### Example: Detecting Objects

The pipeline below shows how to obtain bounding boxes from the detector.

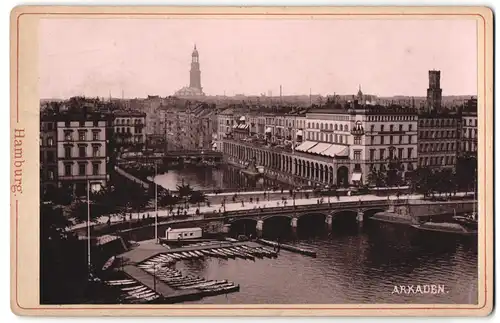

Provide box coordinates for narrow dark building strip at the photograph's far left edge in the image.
[40,113,57,192]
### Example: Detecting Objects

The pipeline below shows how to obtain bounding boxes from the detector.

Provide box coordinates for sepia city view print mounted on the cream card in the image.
[11,5,493,318]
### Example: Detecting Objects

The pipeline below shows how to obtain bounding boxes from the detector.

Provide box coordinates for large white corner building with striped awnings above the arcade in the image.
[296,101,417,186]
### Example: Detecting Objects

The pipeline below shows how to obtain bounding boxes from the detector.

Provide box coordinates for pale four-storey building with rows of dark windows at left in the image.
[56,108,112,196]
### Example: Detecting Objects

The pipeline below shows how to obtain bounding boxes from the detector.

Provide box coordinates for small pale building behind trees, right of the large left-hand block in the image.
[113,111,146,144]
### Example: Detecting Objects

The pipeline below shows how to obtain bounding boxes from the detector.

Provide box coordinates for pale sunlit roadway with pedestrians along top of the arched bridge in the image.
[72,193,466,229]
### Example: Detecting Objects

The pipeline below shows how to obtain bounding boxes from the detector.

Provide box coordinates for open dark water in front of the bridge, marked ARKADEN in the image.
[176,224,478,304]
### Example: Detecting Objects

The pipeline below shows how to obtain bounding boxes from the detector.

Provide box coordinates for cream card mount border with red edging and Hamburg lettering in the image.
[10,6,494,316]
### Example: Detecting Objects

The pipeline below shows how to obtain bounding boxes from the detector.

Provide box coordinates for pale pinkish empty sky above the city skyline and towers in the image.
[39,18,477,98]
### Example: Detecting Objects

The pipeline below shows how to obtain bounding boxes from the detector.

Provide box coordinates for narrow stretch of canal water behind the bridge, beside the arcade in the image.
[155,165,290,190]
